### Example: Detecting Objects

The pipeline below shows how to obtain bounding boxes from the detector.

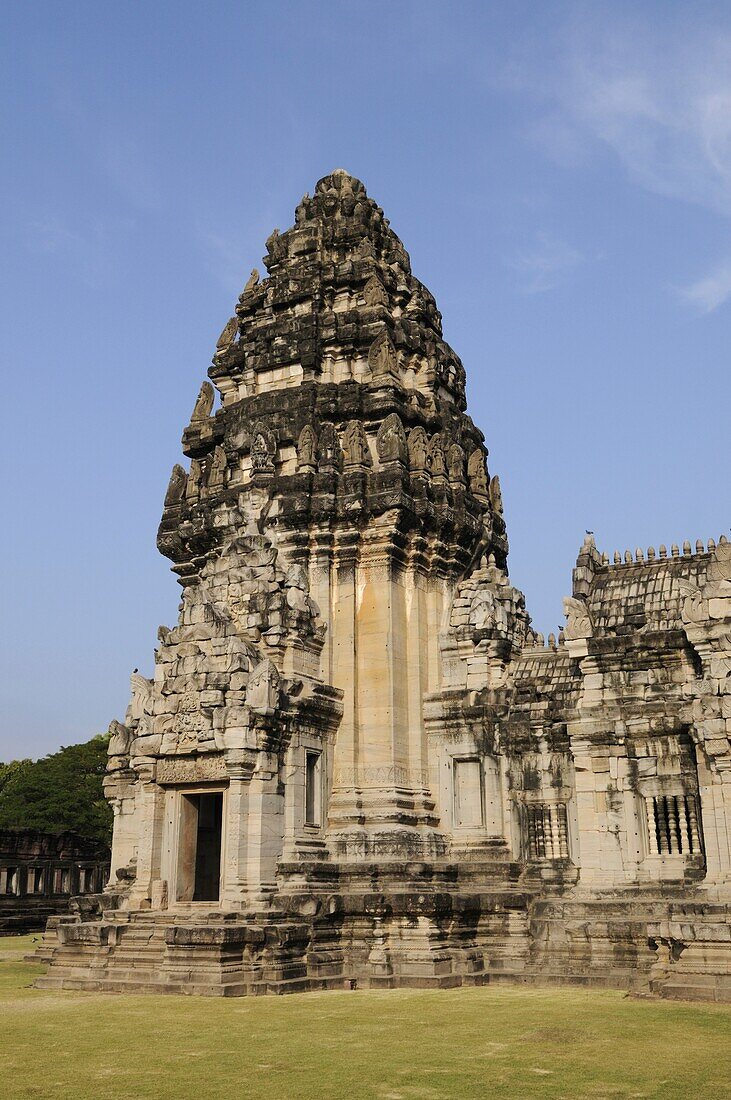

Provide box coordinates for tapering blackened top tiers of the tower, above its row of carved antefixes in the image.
[210,168,465,409]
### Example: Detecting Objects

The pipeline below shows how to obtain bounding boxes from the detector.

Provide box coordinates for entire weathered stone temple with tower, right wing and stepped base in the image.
[38,169,731,1000]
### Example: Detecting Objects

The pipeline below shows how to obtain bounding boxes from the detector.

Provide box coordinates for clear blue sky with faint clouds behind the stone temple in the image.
[0,0,731,759]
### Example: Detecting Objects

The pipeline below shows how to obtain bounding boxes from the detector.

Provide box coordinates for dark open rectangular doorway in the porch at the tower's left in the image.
[177,791,223,901]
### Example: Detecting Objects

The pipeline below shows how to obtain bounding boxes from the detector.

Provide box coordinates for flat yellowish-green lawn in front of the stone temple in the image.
[0,936,731,1100]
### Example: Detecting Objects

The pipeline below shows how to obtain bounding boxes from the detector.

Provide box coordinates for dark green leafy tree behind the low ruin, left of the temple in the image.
[0,735,113,844]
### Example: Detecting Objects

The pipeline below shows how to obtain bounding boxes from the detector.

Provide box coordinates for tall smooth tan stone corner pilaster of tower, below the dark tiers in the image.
[330,525,444,859]
